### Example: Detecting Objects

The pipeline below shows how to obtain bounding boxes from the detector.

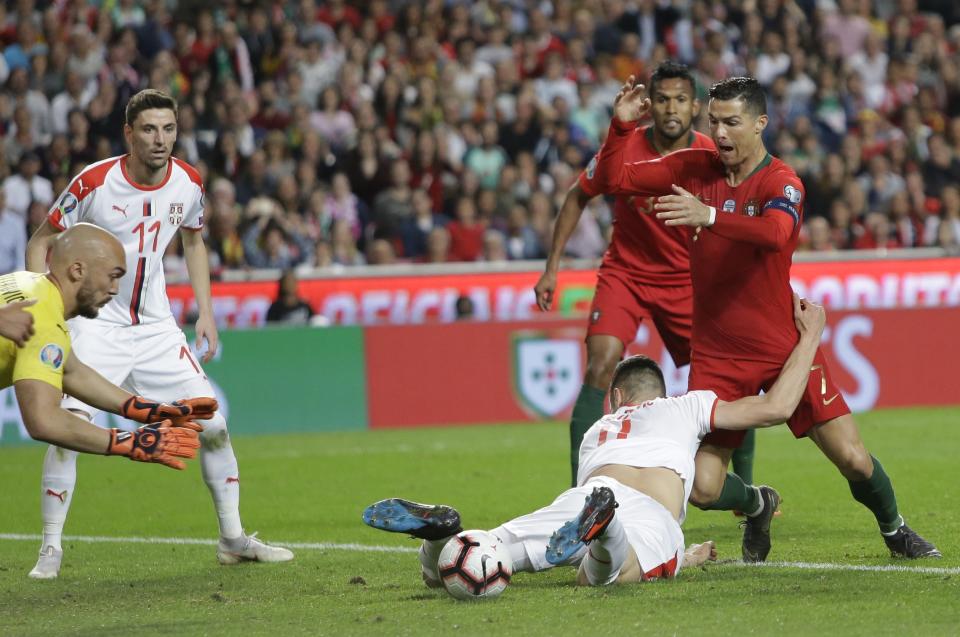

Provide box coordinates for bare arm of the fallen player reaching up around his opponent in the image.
[713,294,827,429]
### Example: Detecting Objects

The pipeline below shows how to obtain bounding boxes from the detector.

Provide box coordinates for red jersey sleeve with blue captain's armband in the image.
[710,166,804,250]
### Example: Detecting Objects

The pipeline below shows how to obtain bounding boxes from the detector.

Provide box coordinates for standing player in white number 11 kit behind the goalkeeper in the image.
[27,89,293,578]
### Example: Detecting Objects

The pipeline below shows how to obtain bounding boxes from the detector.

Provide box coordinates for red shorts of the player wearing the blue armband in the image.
[689,348,850,449]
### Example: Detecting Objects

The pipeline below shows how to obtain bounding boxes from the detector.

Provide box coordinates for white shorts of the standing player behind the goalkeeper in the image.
[61,317,214,418]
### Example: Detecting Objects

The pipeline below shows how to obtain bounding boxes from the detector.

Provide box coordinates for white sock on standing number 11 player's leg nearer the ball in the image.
[200,412,243,539]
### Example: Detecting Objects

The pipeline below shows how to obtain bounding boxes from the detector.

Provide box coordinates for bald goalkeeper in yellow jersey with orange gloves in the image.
[0,224,217,469]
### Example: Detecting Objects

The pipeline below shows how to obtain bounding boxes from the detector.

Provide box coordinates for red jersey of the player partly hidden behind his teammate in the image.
[579,126,714,285]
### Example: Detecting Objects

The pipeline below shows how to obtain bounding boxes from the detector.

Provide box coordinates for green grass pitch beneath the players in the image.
[0,409,960,637]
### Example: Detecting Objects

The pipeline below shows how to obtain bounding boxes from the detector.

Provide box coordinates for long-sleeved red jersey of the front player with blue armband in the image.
[594,120,804,363]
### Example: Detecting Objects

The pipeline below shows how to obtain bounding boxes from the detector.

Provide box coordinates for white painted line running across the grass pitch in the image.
[0,533,960,575]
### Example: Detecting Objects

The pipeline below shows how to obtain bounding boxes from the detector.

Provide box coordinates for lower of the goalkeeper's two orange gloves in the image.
[107,420,200,471]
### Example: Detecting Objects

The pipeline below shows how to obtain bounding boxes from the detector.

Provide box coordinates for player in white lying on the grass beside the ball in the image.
[363,296,826,586]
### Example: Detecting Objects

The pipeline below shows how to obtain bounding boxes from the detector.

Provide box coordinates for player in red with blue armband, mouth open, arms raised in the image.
[594,76,940,561]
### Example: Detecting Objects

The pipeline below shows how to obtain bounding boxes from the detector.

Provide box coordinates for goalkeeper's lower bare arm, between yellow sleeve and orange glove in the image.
[14,379,110,455]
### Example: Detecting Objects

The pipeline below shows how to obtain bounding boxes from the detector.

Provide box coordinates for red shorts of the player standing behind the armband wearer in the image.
[587,268,693,367]
